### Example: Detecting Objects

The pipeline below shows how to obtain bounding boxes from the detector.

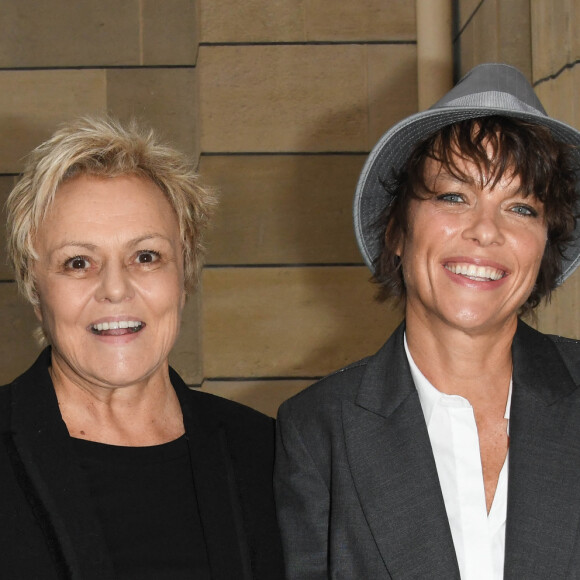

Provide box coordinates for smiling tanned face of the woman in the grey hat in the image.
[397,152,547,333]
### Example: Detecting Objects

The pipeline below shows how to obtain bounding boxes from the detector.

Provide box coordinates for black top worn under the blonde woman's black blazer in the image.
[74,435,210,580]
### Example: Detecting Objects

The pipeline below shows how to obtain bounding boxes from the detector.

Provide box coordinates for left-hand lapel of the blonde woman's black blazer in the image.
[8,349,114,580]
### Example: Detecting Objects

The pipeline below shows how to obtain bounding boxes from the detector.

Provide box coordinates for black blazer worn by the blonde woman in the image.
[0,349,283,580]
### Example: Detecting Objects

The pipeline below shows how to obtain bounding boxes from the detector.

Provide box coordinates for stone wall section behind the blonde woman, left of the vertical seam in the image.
[0,0,202,384]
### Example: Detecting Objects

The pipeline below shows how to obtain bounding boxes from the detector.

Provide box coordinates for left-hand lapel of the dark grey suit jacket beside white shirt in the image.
[343,326,459,580]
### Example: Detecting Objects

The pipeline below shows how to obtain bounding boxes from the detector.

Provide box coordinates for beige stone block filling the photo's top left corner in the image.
[0,0,140,67]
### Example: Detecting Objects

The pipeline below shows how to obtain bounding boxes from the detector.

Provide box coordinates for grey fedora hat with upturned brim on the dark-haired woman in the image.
[353,63,580,284]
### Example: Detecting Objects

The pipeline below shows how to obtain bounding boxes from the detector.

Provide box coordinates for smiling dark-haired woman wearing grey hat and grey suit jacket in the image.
[275,64,580,580]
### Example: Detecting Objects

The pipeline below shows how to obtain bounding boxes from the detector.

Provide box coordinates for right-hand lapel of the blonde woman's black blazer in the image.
[170,371,252,580]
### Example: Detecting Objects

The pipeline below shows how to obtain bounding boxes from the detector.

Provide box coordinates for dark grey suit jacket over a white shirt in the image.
[275,322,580,580]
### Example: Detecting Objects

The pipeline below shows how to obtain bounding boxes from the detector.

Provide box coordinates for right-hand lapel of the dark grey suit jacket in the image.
[505,323,580,580]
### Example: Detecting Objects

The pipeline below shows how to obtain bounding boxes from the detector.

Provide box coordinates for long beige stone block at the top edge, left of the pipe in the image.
[201,0,415,43]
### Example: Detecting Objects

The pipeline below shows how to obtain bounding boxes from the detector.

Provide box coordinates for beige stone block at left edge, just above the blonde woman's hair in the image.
[0,70,106,173]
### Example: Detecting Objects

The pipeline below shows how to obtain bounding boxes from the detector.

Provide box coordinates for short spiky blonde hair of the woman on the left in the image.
[6,117,216,305]
